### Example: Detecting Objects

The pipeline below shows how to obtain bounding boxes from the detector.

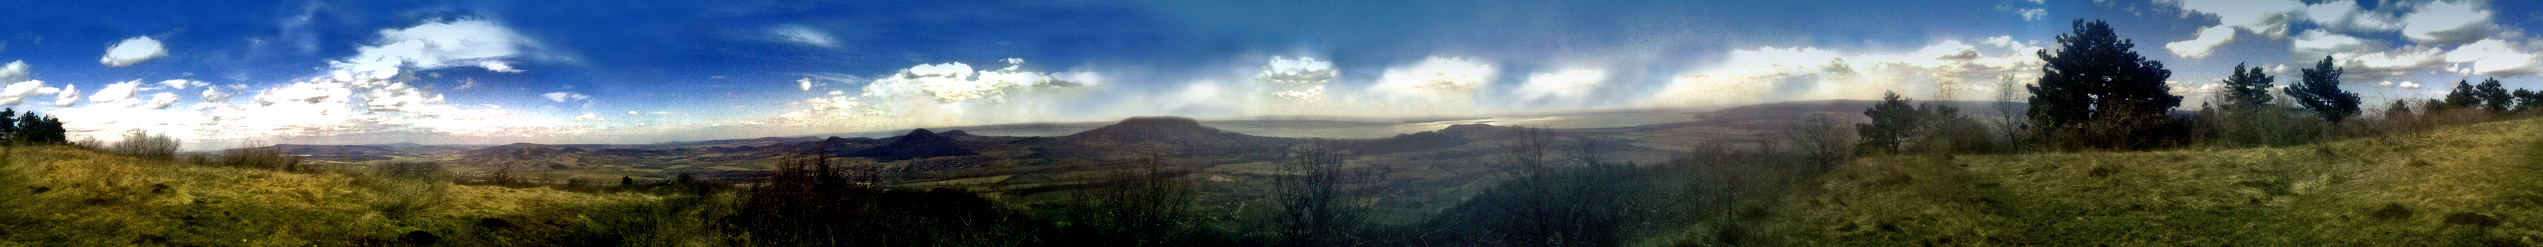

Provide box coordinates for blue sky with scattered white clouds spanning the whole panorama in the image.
[0,0,2543,150]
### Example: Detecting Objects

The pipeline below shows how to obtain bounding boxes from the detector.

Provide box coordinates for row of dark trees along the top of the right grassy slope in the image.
[1856,20,2543,153]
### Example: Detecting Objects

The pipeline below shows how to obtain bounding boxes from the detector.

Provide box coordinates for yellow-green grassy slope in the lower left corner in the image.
[0,145,656,247]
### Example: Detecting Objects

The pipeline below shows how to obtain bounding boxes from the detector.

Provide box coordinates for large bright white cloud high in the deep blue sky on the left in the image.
[328,20,537,74]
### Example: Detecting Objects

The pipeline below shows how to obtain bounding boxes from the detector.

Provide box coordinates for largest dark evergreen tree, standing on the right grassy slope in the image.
[2029,20,2182,148]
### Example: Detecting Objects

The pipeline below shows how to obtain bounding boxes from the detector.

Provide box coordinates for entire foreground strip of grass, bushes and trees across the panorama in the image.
[0,20,2543,247]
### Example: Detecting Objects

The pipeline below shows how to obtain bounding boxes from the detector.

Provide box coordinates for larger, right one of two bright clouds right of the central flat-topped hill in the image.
[1368,56,1498,99]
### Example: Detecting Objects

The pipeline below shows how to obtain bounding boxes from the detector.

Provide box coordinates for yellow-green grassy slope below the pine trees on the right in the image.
[1739,120,2543,247]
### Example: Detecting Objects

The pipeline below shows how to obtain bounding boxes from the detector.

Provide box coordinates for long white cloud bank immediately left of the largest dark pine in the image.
[1645,36,2039,107]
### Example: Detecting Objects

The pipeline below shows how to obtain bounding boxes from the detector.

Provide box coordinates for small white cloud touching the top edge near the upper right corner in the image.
[2401,0,2492,46]
